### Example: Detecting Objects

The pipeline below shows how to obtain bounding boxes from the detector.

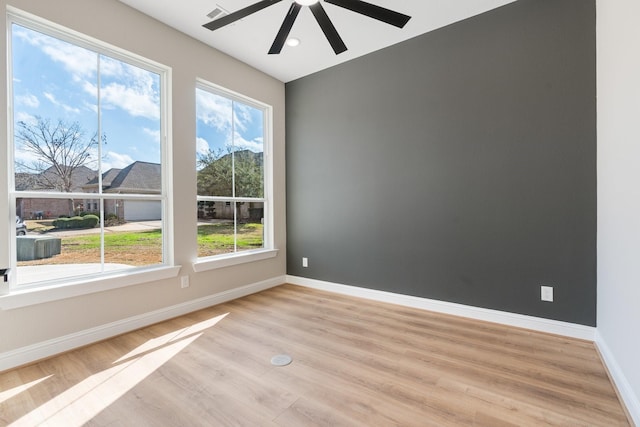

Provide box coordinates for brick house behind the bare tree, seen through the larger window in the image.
[15,166,97,219]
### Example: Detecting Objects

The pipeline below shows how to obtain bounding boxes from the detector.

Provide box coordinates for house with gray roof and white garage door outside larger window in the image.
[82,161,162,221]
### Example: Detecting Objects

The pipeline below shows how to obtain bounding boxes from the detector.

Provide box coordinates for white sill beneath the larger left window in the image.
[0,266,180,310]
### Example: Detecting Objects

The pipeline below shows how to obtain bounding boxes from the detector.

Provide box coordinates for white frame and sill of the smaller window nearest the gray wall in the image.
[192,78,278,272]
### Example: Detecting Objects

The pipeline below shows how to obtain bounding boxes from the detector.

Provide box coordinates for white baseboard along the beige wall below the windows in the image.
[0,276,286,372]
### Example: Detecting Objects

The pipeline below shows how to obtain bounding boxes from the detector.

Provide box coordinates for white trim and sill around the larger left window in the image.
[0,6,181,300]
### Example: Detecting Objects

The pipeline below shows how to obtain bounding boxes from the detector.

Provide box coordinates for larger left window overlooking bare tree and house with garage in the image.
[8,13,172,288]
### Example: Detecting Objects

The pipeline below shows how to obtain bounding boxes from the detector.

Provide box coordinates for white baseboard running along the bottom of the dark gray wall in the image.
[287,276,596,341]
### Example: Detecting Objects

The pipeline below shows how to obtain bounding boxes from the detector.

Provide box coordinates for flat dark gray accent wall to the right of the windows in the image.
[286,0,596,326]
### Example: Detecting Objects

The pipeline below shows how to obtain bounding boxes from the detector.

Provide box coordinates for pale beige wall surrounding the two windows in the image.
[0,0,286,360]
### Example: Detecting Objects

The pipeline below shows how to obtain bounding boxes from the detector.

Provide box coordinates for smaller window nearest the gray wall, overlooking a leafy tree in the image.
[196,82,272,266]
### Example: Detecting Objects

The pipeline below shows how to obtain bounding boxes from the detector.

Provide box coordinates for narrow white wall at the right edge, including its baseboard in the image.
[597,0,640,425]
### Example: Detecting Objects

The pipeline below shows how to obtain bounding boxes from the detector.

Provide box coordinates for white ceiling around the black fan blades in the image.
[120,0,515,82]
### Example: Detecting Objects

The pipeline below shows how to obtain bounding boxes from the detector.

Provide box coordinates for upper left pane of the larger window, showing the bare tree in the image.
[12,24,98,195]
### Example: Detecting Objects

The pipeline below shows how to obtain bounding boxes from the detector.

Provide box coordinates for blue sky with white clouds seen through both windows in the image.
[12,24,264,176]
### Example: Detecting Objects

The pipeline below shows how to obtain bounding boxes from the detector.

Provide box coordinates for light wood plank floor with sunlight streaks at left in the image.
[0,285,629,427]
